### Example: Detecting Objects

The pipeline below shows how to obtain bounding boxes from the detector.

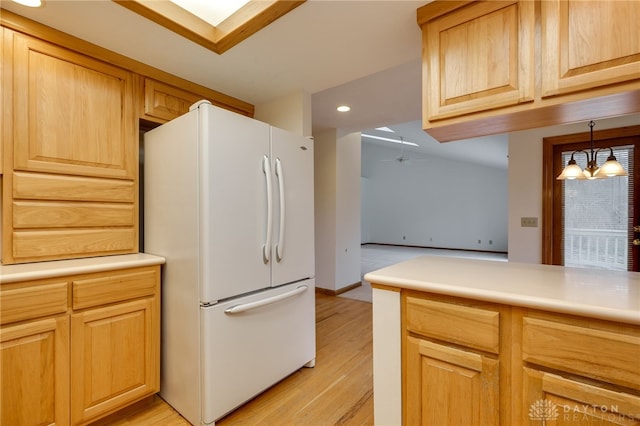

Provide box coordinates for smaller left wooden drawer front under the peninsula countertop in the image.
[406,296,500,354]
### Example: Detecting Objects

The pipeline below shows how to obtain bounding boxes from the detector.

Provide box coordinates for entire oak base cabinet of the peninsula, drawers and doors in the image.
[401,289,640,425]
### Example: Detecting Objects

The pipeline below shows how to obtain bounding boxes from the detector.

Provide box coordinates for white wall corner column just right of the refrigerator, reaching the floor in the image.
[314,129,360,291]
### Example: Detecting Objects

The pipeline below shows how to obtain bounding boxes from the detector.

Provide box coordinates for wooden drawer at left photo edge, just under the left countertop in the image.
[0,281,68,324]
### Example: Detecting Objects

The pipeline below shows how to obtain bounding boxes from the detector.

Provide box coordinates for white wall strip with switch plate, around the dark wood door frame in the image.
[509,114,640,263]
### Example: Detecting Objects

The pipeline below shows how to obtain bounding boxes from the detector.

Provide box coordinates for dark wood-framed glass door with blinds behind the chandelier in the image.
[542,126,640,271]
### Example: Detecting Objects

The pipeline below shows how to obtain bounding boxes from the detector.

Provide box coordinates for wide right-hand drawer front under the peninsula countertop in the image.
[522,317,640,389]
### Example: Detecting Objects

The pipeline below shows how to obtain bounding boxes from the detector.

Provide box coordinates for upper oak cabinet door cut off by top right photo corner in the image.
[540,0,640,97]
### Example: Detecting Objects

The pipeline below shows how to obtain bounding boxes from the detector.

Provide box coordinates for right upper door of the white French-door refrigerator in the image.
[271,127,315,286]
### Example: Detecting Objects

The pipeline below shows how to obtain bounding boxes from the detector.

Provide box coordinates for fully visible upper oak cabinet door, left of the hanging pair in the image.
[422,1,534,120]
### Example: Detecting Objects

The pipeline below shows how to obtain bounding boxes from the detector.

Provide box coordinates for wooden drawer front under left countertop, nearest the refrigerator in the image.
[72,267,159,310]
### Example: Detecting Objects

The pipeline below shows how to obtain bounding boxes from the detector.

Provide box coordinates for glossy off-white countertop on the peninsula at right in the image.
[364,256,640,324]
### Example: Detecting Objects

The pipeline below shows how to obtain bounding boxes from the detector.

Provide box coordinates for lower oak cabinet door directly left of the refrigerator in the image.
[71,298,160,424]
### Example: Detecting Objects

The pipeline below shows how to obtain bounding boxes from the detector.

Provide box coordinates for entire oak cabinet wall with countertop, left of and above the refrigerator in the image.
[0,9,254,426]
